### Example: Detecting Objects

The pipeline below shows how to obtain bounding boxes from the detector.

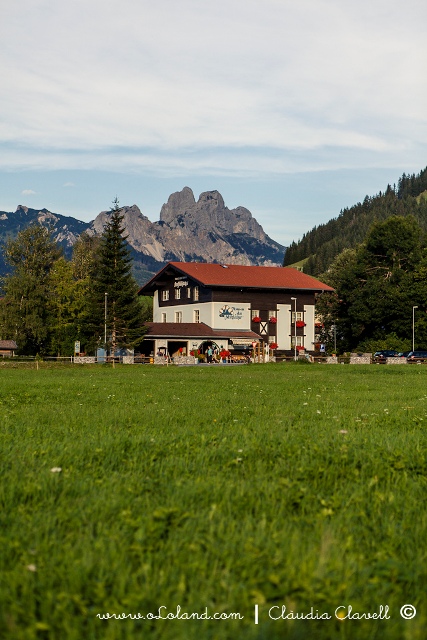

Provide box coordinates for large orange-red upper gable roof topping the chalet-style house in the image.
[141,262,333,291]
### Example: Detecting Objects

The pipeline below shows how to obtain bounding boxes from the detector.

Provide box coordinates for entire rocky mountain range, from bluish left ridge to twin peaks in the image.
[0,187,285,284]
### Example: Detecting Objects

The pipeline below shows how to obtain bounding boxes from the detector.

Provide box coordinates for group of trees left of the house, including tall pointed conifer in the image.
[0,199,151,356]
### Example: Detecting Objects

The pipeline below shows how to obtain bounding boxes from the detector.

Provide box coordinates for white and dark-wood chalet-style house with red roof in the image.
[139,262,333,356]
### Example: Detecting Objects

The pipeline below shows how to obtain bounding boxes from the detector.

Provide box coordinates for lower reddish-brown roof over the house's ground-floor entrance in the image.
[144,322,260,340]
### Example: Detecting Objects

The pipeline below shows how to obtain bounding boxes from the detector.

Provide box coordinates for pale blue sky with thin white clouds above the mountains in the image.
[0,0,427,245]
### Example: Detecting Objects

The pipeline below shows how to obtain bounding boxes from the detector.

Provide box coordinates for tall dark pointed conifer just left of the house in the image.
[94,198,143,353]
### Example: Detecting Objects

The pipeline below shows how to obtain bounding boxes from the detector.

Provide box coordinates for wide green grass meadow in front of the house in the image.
[0,364,427,640]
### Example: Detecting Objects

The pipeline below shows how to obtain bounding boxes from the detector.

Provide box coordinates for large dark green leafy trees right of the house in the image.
[316,215,427,353]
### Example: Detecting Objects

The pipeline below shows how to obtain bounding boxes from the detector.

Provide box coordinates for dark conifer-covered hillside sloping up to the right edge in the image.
[284,167,427,276]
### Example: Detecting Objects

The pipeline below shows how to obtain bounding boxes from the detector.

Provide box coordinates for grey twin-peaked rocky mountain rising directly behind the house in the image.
[88,187,284,274]
